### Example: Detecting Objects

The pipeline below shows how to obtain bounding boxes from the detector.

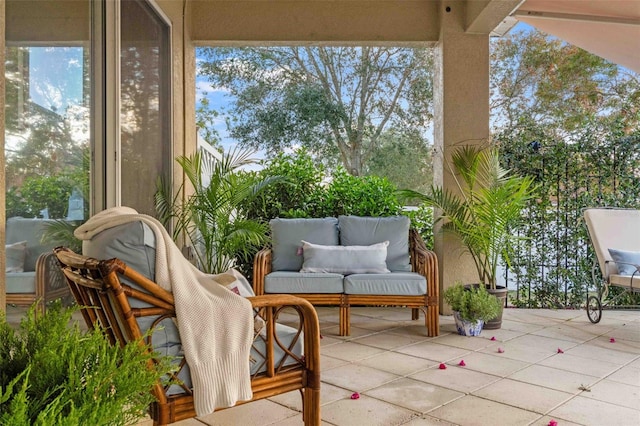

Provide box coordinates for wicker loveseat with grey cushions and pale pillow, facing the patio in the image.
[253,216,439,336]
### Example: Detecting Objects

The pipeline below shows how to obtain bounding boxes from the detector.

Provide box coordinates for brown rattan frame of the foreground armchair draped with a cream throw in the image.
[54,247,320,425]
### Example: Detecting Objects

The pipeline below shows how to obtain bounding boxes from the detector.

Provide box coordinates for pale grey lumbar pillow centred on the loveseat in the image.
[300,240,389,275]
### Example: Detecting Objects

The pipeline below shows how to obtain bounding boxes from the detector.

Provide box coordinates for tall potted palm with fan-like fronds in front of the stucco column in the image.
[402,144,534,329]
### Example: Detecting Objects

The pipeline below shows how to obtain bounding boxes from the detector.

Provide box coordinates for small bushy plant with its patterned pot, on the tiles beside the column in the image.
[443,282,500,336]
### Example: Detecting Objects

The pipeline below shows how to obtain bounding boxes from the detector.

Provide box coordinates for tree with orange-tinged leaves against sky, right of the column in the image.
[490,30,640,136]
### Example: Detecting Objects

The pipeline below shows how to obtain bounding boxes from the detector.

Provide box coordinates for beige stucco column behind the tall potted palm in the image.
[433,1,489,314]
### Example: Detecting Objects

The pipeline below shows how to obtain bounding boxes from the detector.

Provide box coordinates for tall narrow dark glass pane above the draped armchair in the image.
[120,0,171,215]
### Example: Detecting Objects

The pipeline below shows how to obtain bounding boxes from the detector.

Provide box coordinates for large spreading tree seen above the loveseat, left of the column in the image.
[199,47,432,175]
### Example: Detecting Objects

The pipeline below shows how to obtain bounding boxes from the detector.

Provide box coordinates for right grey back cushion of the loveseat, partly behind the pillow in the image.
[338,216,411,272]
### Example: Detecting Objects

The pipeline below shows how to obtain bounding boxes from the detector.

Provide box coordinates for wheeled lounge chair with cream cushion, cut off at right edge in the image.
[584,208,640,324]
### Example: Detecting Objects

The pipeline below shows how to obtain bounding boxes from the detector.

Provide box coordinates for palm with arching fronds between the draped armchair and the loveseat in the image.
[155,149,277,273]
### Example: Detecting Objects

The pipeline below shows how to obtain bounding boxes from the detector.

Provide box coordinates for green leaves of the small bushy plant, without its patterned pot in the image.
[443,283,500,321]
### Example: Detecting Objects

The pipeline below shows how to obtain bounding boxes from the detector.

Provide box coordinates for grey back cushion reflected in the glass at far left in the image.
[5,217,58,272]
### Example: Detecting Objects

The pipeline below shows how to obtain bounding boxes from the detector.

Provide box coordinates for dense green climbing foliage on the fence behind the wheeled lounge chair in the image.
[498,122,640,308]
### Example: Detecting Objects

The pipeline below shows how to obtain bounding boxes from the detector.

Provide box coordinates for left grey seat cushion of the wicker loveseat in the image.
[264,271,344,294]
